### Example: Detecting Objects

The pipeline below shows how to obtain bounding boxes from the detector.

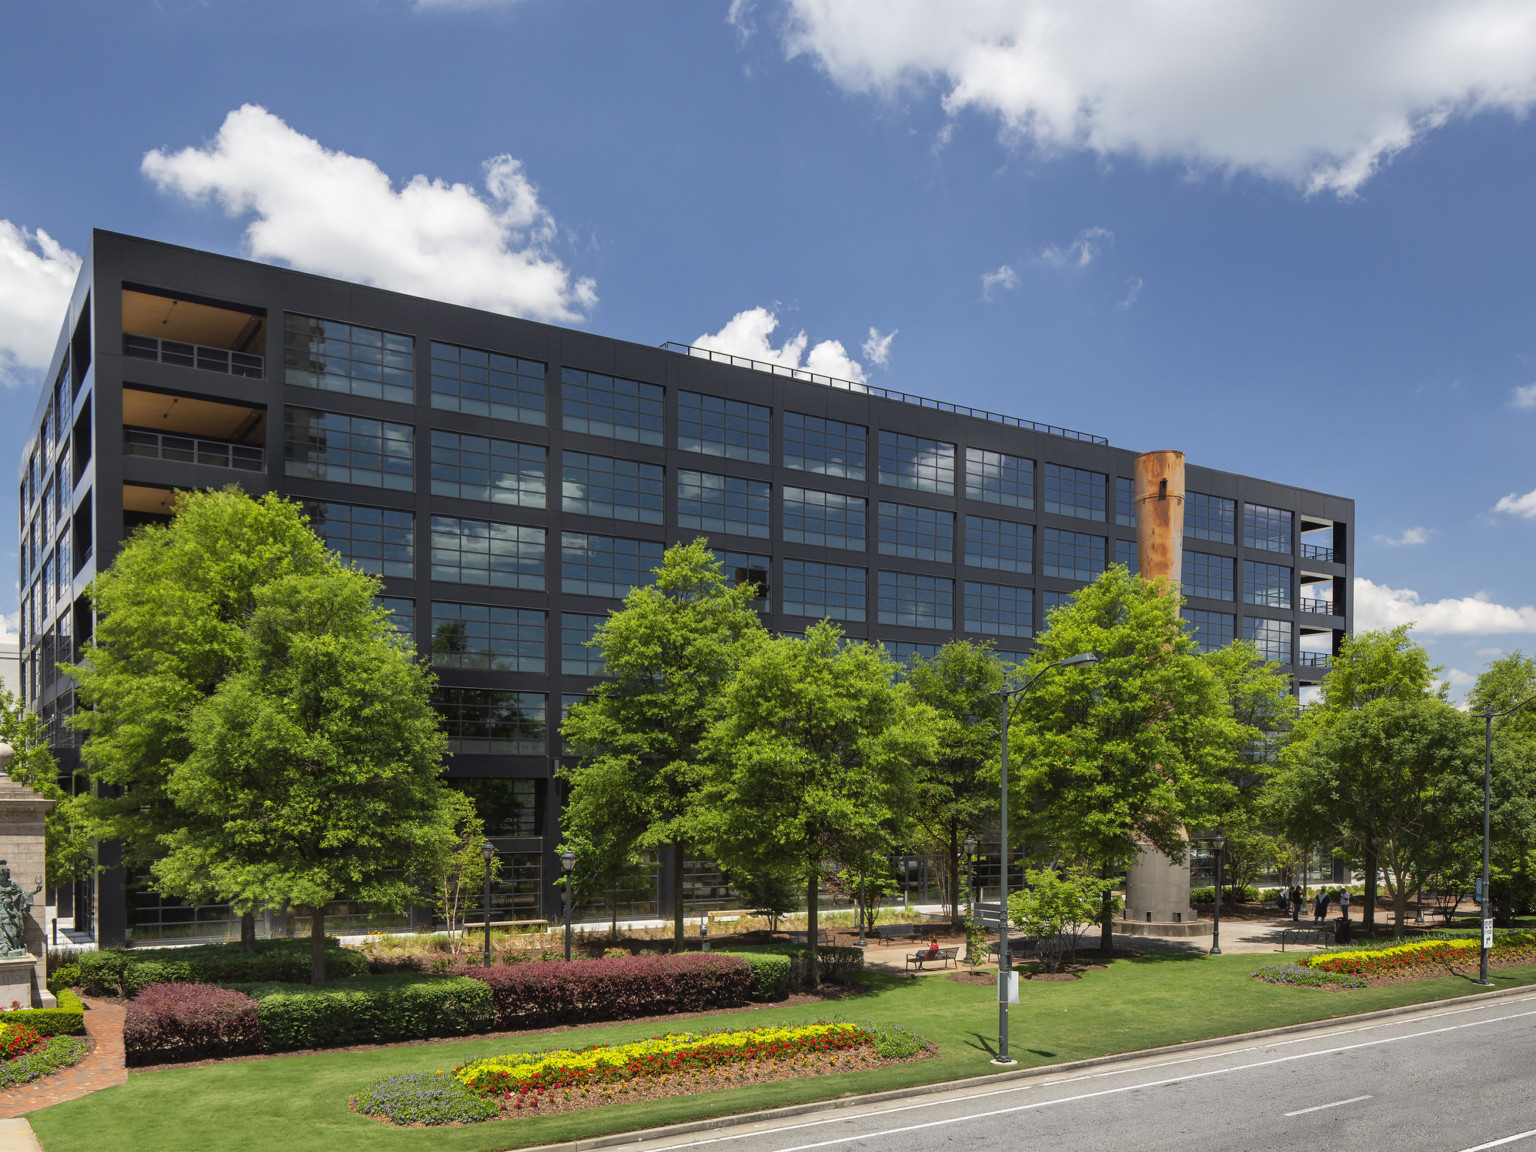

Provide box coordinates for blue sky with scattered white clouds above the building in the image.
[0,0,1536,687]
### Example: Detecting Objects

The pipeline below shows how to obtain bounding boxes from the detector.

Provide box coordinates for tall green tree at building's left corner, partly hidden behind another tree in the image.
[68,485,332,946]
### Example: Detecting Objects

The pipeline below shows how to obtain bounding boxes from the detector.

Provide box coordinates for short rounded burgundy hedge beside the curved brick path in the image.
[123,985,261,1064]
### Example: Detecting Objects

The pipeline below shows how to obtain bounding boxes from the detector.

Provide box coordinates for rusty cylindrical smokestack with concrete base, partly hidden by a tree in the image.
[1115,450,1210,935]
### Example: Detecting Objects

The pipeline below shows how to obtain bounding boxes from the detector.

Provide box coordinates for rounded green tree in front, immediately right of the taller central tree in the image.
[694,621,935,980]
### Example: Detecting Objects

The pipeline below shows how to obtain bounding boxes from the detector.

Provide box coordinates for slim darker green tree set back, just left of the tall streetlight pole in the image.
[906,641,1003,923]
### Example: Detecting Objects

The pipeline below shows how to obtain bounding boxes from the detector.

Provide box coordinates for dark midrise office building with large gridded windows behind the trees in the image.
[17,232,1355,943]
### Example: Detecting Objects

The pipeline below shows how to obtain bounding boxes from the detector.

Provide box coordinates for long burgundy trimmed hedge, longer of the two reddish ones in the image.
[458,952,753,1029]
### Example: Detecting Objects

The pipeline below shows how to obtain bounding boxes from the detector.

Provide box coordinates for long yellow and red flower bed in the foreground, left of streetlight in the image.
[352,1021,935,1124]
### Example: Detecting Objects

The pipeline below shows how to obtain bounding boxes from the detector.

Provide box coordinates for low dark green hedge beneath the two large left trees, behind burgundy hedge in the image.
[62,940,369,995]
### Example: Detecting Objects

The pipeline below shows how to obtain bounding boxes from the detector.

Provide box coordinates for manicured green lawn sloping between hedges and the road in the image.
[29,955,1536,1152]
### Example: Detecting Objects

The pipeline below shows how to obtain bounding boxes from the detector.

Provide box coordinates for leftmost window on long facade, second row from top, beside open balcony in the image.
[283,407,415,492]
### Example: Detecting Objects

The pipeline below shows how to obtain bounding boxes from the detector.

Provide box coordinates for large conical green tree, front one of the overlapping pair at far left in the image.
[151,561,467,986]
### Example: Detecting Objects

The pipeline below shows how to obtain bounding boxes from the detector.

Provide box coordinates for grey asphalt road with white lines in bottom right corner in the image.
[630,992,1536,1152]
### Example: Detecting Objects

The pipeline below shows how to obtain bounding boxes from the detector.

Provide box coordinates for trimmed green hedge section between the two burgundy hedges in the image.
[240,969,496,1052]
